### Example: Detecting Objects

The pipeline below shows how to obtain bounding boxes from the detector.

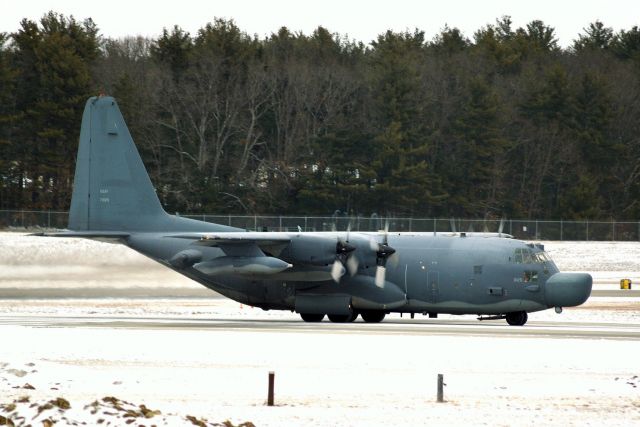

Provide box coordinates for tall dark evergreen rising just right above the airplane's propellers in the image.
[368,30,444,215]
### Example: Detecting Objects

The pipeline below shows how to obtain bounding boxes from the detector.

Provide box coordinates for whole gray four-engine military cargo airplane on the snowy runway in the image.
[44,96,592,325]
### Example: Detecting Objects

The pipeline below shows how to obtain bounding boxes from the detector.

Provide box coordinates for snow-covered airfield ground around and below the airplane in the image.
[0,233,640,426]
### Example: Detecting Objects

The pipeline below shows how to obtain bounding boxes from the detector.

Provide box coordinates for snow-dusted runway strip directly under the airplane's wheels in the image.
[0,315,640,340]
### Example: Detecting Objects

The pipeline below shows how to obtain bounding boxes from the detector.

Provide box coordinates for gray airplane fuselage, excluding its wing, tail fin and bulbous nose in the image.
[125,233,568,314]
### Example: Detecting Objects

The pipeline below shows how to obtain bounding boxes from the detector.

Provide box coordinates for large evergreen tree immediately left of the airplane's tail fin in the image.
[12,12,99,209]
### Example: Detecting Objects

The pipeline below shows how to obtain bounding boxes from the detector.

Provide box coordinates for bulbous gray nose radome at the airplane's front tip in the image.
[544,273,593,307]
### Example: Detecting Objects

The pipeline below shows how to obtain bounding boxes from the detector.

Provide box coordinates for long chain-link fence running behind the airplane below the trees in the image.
[0,210,640,241]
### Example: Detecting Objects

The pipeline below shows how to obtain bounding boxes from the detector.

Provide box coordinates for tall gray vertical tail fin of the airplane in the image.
[68,96,169,231]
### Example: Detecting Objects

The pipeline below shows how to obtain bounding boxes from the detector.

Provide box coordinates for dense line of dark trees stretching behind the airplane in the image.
[0,12,640,219]
